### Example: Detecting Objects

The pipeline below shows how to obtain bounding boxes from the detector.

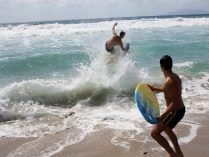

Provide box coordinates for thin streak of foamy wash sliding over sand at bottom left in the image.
[8,130,85,157]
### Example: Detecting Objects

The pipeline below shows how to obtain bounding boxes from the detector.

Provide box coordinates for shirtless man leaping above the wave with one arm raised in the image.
[105,23,126,54]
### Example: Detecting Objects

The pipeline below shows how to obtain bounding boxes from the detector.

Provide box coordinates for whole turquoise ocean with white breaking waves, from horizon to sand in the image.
[0,15,209,156]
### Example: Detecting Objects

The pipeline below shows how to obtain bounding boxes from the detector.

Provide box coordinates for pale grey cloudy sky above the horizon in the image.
[0,0,209,23]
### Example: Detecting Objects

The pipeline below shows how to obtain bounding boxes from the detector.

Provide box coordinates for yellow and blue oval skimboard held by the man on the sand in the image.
[134,83,160,124]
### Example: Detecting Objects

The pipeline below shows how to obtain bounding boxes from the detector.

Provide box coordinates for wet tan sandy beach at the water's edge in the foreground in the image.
[0,114,209,157]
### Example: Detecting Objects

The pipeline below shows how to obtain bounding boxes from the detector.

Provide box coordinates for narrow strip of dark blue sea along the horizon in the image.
[0,14,209,27]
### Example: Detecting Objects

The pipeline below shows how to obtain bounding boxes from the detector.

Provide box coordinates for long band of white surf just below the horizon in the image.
[0,17,209,38]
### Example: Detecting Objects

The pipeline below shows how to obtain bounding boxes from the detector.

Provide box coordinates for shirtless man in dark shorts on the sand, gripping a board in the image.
[149,55,185,157]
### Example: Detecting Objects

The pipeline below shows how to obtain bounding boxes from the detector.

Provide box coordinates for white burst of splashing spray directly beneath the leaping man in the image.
[73,50,148,91]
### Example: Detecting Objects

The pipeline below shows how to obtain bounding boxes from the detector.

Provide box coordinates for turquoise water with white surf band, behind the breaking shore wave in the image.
[0,17,209,86]
